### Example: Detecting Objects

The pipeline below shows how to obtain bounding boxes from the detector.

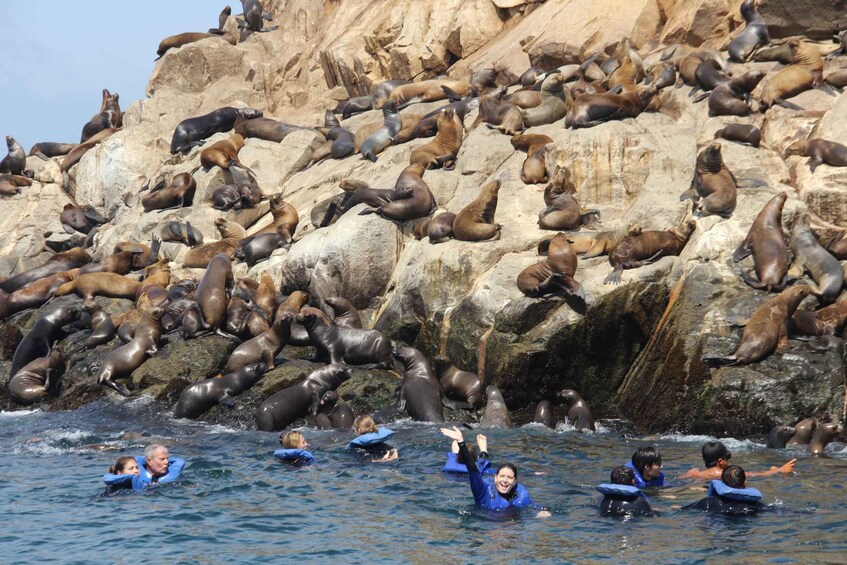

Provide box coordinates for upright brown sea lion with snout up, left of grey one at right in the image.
[732,192,788,292]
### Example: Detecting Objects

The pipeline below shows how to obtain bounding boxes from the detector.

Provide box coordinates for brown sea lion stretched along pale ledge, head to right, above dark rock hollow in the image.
[603,220,697,284]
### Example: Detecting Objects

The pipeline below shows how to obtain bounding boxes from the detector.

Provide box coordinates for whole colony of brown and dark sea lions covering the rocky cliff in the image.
[0,0,847,440]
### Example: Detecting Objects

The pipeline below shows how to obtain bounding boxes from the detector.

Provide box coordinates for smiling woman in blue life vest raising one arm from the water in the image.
[441,427,550,518]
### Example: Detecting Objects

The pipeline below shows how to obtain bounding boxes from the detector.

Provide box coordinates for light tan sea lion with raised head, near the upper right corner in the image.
[759,39,823,112]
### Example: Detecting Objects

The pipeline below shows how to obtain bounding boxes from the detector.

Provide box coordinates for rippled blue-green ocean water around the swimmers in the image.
[0,399,847,564]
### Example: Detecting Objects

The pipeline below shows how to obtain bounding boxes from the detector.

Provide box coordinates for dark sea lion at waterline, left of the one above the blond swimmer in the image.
[174,363,265,420]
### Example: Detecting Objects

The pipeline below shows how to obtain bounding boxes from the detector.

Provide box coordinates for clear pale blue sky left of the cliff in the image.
[0,0,229,152]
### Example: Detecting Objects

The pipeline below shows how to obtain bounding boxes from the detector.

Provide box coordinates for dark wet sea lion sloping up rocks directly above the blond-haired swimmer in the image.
[256,363,350,432]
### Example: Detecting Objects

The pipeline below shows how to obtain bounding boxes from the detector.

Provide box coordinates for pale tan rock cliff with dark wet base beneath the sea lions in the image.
[0,0,847,435]
